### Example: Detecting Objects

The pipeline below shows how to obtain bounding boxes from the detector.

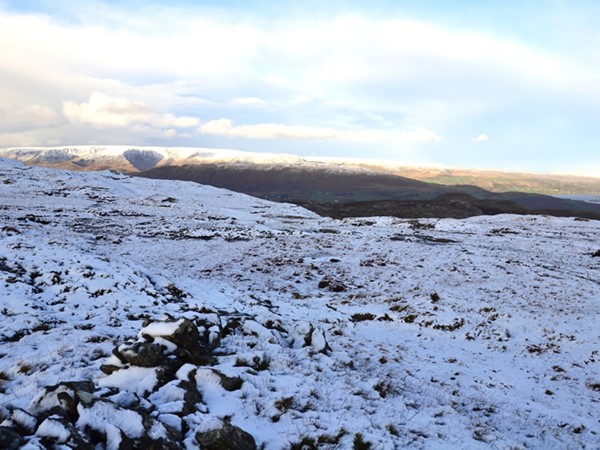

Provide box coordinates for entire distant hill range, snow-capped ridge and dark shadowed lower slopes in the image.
[0,146,600,220]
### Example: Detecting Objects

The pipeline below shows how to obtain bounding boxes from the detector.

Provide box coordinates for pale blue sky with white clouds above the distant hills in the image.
[0,0,600,177]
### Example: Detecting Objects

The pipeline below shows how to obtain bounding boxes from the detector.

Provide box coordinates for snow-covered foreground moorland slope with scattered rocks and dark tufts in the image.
[0,159,600,450]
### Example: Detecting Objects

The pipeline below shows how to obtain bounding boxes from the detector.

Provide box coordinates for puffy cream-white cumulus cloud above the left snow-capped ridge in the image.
[63,92,199,128]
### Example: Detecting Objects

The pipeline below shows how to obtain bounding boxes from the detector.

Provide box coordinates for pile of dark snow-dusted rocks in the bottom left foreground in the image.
[0,317,256,450]
